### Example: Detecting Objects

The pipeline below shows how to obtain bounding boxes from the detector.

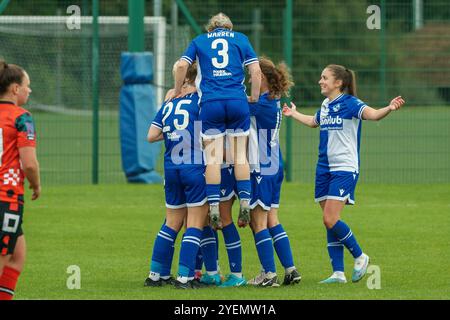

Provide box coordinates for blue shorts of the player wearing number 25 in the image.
[164,166,207,209]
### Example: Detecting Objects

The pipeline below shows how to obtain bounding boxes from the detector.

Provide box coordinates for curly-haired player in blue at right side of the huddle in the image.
[244,57,301,287]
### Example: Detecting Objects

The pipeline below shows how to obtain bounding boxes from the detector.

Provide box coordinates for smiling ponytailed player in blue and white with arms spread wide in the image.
[283,64,405,283]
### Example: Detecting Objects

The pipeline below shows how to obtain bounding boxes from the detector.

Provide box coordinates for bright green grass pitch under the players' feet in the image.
[16,183,450,300]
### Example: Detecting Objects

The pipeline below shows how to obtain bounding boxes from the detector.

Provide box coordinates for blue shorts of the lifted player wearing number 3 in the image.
[200,99,250,139]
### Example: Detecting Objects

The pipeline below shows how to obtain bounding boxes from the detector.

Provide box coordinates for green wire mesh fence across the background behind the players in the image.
[0,0,450,184]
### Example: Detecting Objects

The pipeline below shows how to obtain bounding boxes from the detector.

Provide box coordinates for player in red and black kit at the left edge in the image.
[0,61,41,300]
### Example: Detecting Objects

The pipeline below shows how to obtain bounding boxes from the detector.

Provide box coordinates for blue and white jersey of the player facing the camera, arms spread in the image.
[314,94,367,173]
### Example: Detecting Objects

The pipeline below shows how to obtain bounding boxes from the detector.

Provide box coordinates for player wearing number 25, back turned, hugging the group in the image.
[145,64,208,289]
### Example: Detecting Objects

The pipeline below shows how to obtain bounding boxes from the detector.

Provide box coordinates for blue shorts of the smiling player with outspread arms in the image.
[314,170,359,204]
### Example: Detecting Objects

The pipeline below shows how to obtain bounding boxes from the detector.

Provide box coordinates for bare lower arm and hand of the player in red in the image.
[19,147,41,200]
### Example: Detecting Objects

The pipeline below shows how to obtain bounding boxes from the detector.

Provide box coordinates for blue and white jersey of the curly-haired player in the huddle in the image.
[248,93,283,175]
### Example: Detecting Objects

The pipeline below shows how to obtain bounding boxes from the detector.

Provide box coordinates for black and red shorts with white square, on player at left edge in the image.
[0,201,23,256]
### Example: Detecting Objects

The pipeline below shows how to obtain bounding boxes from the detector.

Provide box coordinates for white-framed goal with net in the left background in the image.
[0,16,189,112]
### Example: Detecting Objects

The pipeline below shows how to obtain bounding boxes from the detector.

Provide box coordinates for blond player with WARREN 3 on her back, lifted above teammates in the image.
[172,13,261,228]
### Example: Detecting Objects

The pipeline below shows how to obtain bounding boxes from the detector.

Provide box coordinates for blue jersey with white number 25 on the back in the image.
[152,93,203,169]
